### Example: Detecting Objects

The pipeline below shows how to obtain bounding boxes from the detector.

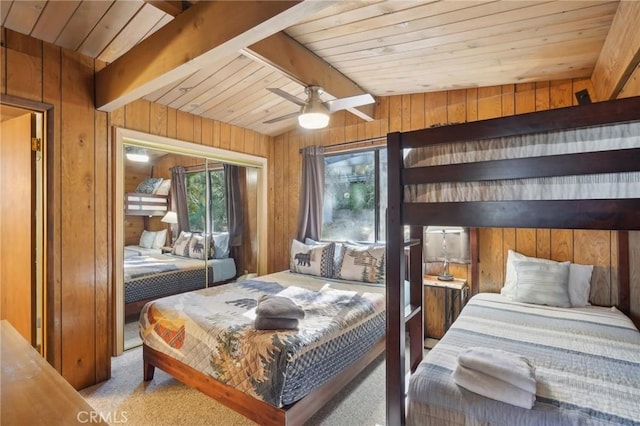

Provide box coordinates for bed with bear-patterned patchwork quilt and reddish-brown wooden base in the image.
[140,271,385,425]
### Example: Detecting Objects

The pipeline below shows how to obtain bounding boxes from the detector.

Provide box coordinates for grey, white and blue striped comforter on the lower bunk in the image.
[407,293,640,426]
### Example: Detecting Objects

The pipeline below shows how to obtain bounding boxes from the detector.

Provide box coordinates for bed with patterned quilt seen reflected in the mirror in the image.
[124,253,236,316]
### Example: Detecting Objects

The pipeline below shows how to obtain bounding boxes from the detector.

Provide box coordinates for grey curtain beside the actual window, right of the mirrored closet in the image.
[298,146,324,242]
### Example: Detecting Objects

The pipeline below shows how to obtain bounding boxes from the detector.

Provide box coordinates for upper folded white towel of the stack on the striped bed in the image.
[458,347,536,393]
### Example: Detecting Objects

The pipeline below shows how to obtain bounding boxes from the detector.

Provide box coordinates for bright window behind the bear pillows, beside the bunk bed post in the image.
[321,148,387,242]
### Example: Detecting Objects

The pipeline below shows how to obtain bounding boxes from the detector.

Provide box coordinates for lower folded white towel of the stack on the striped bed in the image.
[453,364,536,409]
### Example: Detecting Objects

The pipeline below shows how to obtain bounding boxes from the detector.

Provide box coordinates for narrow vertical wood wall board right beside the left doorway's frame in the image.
[42,43,63,373]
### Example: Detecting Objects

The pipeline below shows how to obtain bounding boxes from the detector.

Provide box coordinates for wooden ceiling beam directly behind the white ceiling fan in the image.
[243,31,374,121]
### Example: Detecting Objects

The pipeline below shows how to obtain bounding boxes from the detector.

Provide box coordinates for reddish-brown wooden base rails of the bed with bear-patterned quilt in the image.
[142,338,385,426]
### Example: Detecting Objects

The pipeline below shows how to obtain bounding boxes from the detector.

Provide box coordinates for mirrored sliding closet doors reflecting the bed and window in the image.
[123,145,257,350]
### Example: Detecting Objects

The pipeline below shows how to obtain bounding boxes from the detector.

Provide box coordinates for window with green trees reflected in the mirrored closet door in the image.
[186,169,227,232]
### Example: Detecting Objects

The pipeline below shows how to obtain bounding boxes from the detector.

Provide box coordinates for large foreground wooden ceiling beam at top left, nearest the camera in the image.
[96,1,332,112]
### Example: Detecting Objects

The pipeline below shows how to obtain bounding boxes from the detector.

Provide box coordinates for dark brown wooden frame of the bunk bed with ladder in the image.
[386,97,640,425]
